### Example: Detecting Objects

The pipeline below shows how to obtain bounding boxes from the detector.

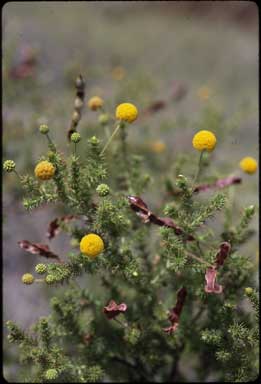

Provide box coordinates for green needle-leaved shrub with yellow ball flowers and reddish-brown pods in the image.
[4,76,258,382]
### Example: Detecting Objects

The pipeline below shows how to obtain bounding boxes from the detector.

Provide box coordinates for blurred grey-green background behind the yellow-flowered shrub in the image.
[2,1,258,381]
